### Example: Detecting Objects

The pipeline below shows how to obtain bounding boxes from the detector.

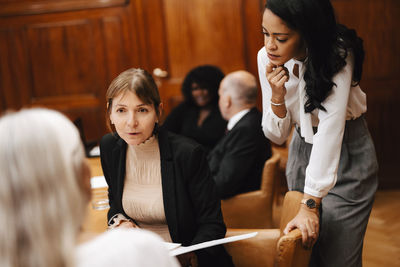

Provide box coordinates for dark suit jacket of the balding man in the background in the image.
[208,108,271,198]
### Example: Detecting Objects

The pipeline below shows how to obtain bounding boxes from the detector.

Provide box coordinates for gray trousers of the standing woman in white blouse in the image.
[286,116,378,267]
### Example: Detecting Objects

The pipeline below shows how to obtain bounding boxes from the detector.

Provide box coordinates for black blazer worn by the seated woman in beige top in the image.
[100,129,232,266]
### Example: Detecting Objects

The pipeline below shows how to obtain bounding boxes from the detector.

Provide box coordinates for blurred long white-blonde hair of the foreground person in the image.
[0,108,87,267]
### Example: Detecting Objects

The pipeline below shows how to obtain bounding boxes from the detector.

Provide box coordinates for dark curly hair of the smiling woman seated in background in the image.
[182,65,225,105]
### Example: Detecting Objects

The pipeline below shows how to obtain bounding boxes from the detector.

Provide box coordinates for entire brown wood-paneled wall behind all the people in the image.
[0,0,400,188]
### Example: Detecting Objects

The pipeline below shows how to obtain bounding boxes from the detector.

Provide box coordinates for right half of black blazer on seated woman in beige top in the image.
[159,131,232,267]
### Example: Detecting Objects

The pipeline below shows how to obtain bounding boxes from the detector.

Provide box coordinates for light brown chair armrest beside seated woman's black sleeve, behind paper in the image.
[224,228,281,267]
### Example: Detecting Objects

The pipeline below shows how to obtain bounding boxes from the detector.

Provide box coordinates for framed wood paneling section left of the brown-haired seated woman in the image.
[0,1,142,140]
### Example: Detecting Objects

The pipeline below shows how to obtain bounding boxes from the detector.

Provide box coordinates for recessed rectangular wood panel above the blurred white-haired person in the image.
[27,19,98,98]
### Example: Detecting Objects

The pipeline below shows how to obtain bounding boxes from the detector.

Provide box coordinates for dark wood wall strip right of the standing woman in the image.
[332,0,400,188]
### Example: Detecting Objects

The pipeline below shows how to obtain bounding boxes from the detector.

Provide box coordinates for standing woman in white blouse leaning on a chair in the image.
[258,0,378,266]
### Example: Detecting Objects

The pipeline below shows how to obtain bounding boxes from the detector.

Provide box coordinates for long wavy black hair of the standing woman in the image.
[265,0,364,112]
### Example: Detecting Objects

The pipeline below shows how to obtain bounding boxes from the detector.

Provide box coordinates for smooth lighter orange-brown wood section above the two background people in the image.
[155,0,262,118]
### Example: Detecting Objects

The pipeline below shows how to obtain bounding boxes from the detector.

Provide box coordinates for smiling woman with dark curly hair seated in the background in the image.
[163,65,227,151]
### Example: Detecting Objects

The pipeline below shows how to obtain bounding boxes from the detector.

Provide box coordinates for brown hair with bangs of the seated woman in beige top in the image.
[106,68,161,131]
